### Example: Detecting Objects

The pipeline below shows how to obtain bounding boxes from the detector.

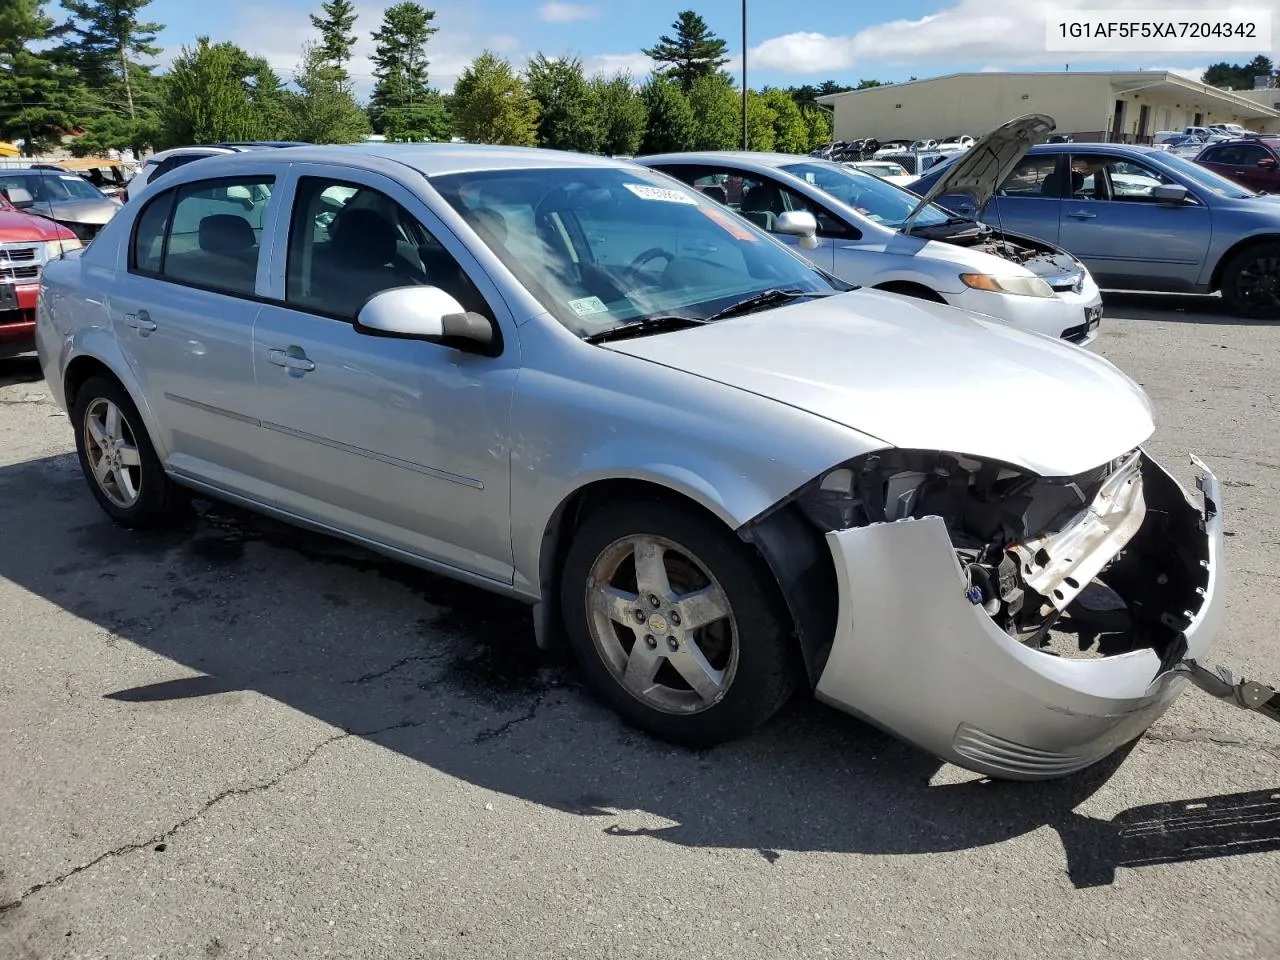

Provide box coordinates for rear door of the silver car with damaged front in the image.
[102,174,274,498]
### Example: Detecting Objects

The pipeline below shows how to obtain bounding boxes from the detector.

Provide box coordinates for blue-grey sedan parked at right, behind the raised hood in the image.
[910,135,1280,319]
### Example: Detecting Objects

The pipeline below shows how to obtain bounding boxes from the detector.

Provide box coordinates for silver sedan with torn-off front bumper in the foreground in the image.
[37,145,1222,778]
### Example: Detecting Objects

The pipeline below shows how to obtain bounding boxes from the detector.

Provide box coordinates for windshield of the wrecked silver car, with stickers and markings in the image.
[431,166,847,337]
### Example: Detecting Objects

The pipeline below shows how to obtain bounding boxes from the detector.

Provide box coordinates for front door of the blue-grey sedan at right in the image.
[1059,154,1211,291]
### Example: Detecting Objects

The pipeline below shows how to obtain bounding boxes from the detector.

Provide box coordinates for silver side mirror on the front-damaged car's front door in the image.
[356,287,498,353]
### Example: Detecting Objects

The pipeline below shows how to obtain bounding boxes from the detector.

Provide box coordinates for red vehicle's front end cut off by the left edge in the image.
[0,192,81,358]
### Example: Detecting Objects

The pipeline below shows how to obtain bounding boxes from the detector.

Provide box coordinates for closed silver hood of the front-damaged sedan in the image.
[602,289,1153,476]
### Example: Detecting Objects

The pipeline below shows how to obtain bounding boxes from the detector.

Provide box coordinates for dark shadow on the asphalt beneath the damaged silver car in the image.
[0,456,1280,887]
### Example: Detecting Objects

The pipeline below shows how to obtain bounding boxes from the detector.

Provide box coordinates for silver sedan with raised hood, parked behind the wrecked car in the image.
[636,131,1102,343]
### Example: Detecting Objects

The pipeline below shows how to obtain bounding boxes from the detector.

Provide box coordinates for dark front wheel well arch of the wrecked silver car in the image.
[535,477,747,649]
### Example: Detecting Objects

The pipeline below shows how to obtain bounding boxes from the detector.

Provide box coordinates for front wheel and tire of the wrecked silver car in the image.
[561,500,797,748]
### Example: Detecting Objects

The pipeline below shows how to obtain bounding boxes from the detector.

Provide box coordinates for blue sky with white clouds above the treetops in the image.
[137,0,1280,91]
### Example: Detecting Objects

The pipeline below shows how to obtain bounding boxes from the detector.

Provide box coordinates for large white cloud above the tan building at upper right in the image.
[749,0,1280,76]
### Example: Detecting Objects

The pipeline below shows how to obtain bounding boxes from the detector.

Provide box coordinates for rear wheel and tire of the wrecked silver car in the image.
[72,376,186,527]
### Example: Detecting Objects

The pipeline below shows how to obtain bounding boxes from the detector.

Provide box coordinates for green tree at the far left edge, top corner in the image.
[0,0,84,156]
